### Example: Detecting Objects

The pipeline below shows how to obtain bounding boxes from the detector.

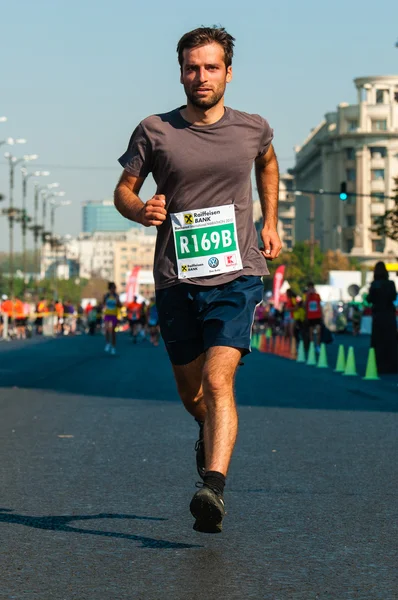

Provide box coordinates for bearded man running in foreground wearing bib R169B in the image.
[115,27,281,533]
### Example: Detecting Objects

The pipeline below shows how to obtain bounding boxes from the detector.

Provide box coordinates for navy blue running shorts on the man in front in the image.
[156,275,264,365]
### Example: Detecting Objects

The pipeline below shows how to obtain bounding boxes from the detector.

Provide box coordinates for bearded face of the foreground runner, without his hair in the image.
[181,43,232,110]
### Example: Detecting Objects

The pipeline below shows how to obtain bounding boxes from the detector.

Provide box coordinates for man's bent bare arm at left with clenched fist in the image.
[114,171,167,227]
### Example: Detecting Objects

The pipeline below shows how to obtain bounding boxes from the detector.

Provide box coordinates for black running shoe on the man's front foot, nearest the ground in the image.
[189,485,225,533]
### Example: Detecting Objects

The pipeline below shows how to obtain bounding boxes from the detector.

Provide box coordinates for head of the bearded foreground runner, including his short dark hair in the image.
[177,27,234,110]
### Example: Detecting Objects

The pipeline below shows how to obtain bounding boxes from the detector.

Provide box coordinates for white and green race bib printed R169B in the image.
[170,204,242,279]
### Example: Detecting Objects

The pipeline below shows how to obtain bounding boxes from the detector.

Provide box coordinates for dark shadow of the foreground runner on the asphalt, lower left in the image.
[0,508,201,550]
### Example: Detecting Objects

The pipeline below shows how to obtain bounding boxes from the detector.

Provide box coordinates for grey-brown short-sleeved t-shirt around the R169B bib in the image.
[119,107,273,289]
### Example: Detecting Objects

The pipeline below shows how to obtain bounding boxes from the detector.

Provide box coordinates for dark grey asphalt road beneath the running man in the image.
[0,335,398,600]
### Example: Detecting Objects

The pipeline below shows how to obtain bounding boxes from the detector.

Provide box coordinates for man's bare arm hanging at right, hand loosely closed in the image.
[255,144,282,260]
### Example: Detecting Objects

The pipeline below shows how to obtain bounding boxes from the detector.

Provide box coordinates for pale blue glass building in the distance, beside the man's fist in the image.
[82,200,141,233]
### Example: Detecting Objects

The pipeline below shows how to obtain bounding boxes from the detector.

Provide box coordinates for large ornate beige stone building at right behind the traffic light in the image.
[293,75,398,262]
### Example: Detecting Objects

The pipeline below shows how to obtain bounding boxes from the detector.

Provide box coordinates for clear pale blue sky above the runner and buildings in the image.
[0,0,398,250]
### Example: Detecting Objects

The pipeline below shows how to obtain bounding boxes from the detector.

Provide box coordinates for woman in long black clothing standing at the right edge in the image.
[368,262,398,373]
